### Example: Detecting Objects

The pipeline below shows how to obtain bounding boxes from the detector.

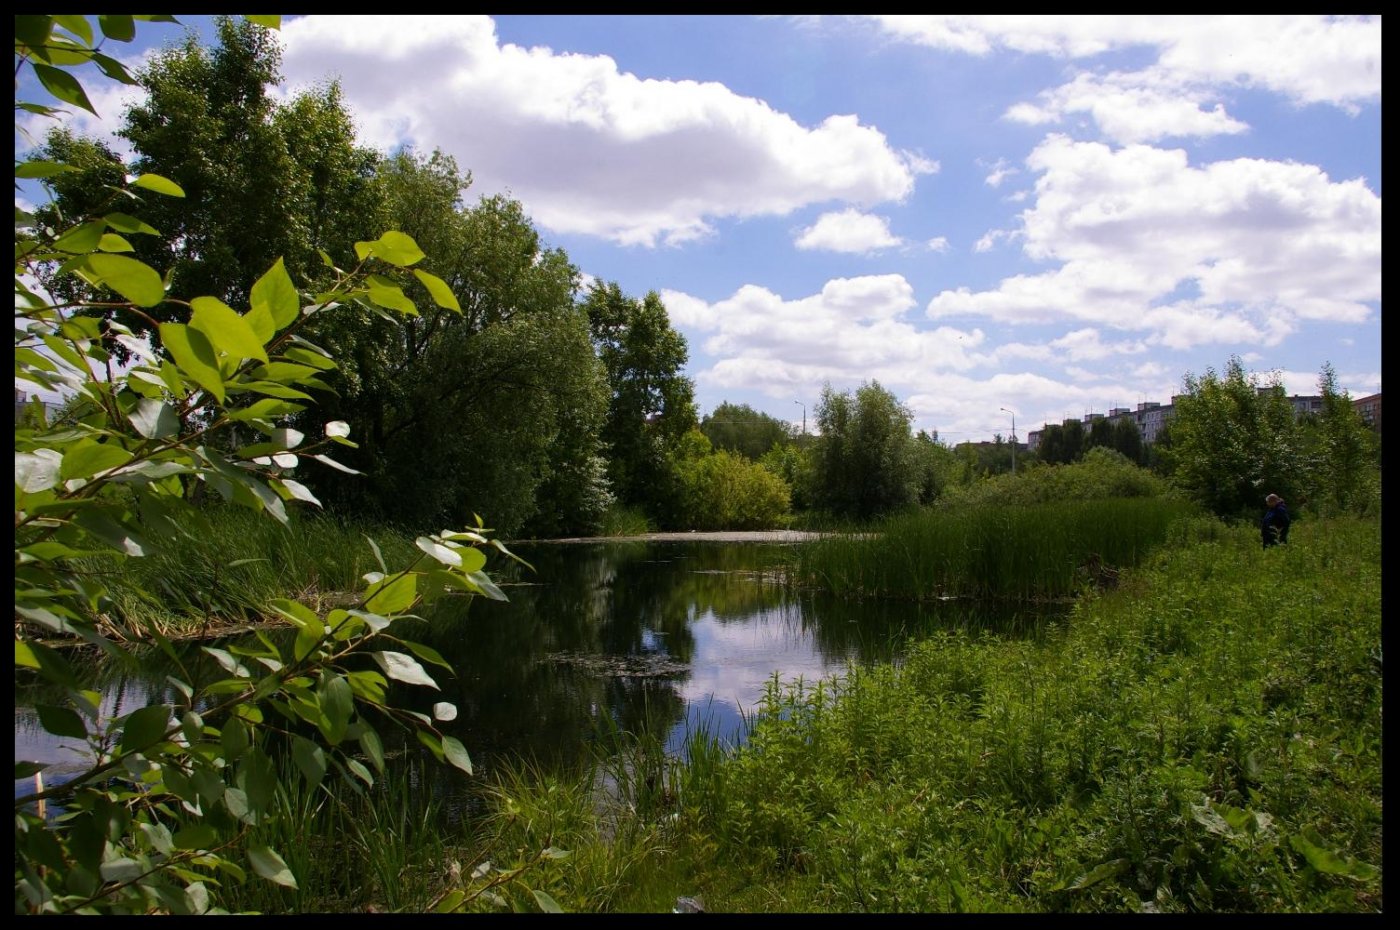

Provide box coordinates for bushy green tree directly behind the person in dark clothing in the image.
[1163,357,1305,517]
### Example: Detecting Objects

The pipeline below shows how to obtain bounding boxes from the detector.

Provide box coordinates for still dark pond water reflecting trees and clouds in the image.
[15,541,1046,791]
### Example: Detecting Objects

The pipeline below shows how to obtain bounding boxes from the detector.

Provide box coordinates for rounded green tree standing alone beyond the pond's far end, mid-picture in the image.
[812,381,918,520]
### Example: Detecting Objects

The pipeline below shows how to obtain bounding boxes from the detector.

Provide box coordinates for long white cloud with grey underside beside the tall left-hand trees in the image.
[281,15,938,247]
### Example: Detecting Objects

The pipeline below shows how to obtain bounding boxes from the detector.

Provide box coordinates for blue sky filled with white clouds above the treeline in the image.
[17,15,1380,443]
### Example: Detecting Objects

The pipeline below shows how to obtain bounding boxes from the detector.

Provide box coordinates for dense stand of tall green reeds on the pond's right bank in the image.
[792,497,1193,601]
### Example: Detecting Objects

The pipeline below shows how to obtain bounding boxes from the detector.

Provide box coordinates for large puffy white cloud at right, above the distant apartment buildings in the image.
[927,136,1380,347]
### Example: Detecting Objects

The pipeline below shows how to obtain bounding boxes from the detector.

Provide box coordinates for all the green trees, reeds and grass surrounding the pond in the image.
[14,14,1383,915]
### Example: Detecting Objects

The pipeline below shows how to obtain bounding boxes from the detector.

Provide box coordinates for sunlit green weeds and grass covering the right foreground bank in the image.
[467,520,1383,913]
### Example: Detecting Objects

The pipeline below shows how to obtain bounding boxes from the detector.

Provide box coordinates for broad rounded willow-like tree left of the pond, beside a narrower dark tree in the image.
[301,151,612,534]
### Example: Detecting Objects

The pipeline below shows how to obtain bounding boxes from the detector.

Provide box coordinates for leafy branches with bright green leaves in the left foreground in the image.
[14,14,532,915]
